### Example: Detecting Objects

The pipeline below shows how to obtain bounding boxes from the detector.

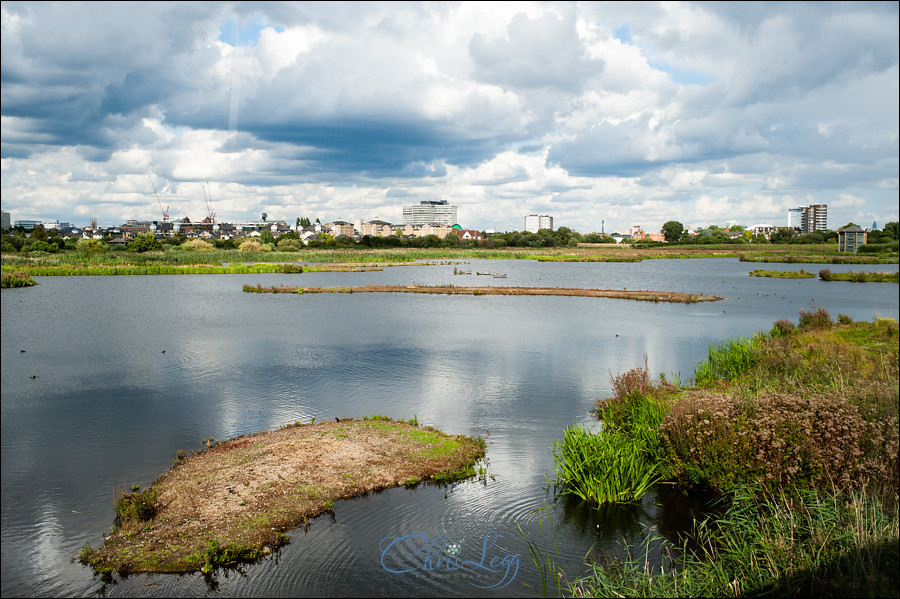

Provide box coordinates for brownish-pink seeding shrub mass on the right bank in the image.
[659,391,898,491]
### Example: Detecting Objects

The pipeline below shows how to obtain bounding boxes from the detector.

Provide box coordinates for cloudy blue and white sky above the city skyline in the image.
[0,1,900,233]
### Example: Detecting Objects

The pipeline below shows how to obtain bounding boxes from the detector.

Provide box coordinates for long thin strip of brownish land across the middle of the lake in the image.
[244,285,722,304]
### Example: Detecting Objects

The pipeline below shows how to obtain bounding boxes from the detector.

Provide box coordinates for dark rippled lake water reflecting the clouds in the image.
[0,259,898,597]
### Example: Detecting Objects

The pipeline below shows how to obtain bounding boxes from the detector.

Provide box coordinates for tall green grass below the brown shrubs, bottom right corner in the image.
[567,487,900,597]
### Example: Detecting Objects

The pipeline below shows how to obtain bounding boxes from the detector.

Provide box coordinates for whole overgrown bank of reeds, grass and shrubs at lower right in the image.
[528,309,900,597]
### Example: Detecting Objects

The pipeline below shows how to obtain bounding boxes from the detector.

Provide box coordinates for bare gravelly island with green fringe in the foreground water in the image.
[80,416,485,575]
